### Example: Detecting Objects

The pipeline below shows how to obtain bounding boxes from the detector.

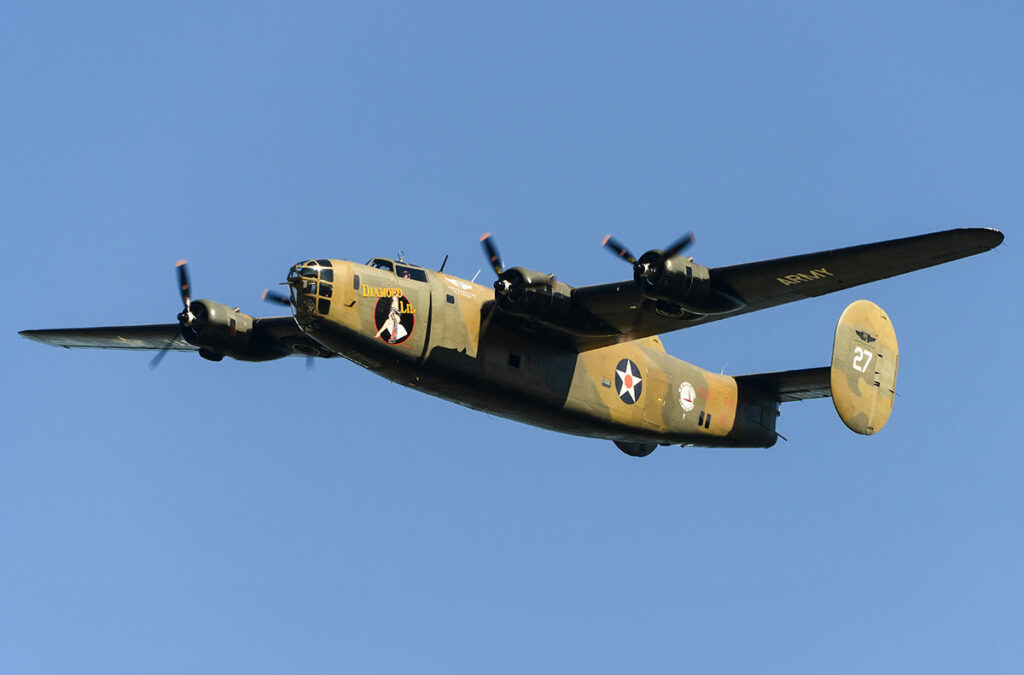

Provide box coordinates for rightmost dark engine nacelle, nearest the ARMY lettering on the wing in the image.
[633,250,743,315]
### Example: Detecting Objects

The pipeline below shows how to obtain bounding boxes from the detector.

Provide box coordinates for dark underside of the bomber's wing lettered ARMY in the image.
[561,227,1002,349]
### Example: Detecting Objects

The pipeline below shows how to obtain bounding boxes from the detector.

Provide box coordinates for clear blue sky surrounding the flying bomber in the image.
[0,2,1024,675]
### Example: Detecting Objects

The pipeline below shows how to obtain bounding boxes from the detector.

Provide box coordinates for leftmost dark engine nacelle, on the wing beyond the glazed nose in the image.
[181,300,287,361]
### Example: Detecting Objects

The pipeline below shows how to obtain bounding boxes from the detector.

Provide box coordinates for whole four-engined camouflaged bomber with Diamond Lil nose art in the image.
[20,228,1002,457]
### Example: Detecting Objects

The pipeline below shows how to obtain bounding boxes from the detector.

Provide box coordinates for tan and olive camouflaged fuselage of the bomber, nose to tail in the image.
[293,259,776,454]
